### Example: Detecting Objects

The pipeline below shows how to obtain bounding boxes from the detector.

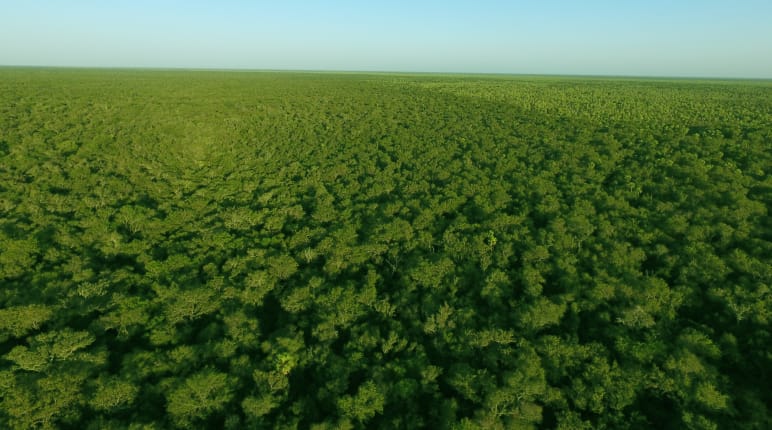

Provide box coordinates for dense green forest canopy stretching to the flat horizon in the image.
[0,68,772,430]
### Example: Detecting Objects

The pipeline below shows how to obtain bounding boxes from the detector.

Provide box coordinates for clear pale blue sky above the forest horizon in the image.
[0,0,772,78]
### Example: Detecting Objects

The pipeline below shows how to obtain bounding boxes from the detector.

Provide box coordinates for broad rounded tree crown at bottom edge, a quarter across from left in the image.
[167,370,233,428]
